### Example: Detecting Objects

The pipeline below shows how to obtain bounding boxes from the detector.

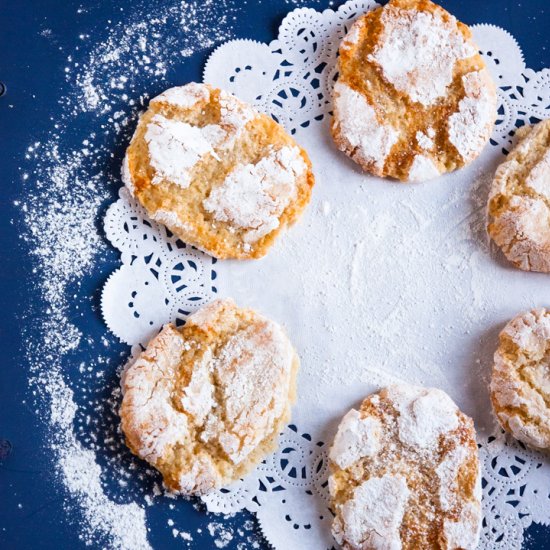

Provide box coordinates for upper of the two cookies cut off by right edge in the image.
[488,120,550,273]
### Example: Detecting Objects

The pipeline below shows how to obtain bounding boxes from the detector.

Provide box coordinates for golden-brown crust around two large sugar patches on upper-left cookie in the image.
[123,84,314,259]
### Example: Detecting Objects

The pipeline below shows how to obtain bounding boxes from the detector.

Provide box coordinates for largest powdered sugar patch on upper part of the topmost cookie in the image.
[369,5,476,106]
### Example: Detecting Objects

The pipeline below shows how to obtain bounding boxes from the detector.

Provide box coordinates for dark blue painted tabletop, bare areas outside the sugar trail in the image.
[0,0,550,550]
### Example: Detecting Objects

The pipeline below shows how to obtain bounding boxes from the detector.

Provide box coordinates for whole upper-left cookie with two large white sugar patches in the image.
[122,83,314,258]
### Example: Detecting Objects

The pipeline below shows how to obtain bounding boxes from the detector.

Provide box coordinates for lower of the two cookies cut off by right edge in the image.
[491,309,550,450]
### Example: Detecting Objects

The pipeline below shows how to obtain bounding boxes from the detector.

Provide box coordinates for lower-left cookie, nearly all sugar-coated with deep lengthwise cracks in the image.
[120,300,299,495]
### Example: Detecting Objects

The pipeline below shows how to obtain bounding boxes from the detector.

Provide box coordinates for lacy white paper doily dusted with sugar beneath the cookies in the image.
[102,0,550,550]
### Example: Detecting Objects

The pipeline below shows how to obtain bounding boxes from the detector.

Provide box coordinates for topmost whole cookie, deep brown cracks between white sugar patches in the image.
[332,0,496,181]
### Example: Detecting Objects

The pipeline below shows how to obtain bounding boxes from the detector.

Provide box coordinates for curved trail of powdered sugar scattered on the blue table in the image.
[14,0,244,549]
